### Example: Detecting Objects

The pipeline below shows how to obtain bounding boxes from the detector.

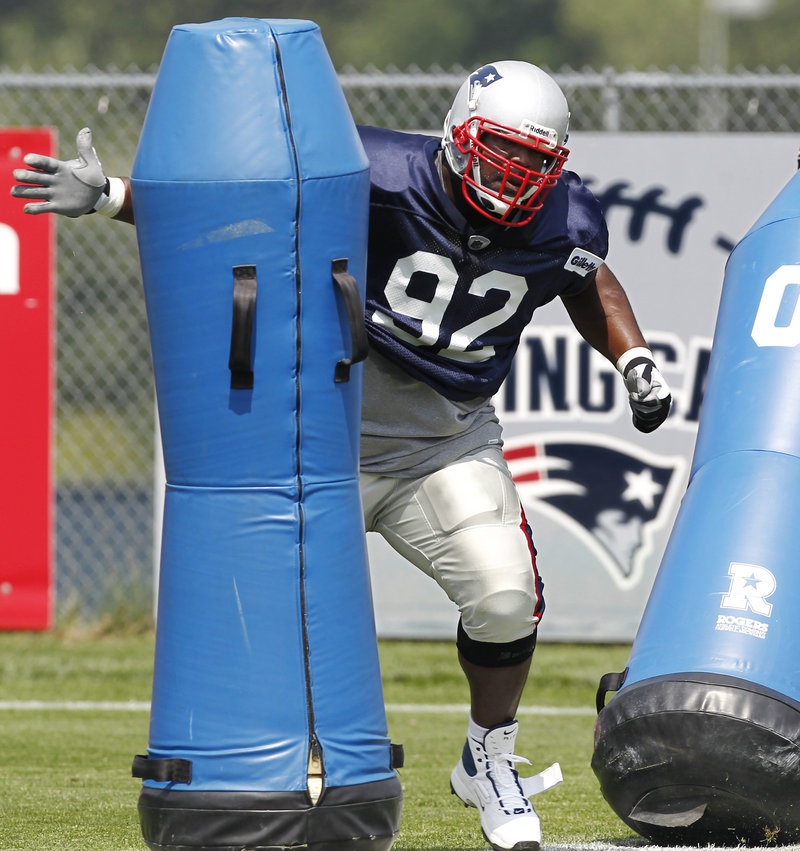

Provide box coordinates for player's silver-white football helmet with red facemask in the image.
[442,60,569,227]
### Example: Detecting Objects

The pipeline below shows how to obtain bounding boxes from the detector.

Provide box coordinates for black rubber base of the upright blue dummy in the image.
[139,777,402,851]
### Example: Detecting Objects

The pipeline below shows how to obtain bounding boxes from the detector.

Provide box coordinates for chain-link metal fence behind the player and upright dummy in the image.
[0,68,800,620]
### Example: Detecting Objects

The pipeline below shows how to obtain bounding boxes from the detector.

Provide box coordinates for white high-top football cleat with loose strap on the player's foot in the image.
[450,721,562,851]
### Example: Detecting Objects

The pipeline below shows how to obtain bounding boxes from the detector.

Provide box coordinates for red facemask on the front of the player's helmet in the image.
[452,116,569,227]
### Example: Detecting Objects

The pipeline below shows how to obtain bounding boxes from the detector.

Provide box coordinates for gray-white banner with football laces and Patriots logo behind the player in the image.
[368,133,798,641]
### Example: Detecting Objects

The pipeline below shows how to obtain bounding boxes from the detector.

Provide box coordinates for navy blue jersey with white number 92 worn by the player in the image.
[359,127,608,400]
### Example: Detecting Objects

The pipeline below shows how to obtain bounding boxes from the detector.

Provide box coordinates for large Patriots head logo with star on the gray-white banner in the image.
[510,432,685,588]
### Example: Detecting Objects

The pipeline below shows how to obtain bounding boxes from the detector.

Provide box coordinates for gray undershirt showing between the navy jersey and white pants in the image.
[361,349,502,478]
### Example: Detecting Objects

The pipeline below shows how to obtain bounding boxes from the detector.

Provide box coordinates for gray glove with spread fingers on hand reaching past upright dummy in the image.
[11,127,108,219]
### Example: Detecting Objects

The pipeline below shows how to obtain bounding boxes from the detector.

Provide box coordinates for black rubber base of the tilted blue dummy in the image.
[592,674,800,845]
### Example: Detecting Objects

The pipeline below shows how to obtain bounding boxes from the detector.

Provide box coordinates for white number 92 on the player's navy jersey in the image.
[372,251,528,363]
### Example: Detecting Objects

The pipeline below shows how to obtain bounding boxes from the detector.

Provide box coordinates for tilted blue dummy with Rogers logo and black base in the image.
[592,166,800,845]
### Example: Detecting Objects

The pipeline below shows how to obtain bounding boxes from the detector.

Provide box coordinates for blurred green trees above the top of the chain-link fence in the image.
[0,0,800,71]
